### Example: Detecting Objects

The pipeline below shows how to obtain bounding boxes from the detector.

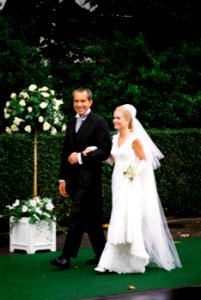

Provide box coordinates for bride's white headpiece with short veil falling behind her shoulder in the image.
[122,104,164,169]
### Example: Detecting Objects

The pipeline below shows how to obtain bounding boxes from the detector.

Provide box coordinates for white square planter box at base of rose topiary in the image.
[10,217,56,253]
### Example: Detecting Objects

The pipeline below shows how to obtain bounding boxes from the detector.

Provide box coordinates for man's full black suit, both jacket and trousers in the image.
[59,111,111,257]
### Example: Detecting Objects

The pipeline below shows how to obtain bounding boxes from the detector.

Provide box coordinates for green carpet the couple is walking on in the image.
[0,238,201,300]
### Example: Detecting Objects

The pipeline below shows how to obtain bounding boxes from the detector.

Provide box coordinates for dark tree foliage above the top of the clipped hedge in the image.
[0,0,201,132]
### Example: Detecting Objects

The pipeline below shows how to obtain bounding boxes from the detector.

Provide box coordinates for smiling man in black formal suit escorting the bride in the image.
[50,88,111,269]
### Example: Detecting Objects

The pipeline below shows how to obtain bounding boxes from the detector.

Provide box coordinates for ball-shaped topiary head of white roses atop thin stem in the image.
[4,84,66,135]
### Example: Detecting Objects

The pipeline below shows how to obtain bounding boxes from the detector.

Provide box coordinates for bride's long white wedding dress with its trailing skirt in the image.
[95,133,181,274]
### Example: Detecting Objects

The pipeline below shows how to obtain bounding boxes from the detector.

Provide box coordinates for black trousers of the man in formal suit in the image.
[63,186,106,258]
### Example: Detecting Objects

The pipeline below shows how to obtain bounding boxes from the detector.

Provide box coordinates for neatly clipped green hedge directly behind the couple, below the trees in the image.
[0,129,201,223]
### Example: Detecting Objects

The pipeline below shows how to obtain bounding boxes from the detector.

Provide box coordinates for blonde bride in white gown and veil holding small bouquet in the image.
[82,104,181,274]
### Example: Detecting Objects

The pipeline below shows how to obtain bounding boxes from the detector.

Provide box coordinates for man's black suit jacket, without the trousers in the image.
[59,111,111,193]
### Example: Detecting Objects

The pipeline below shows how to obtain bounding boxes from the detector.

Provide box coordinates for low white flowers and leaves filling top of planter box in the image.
[4,197,56,226]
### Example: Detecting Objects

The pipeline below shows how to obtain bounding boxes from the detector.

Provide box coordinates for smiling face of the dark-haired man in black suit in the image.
[73,91,93,116]
